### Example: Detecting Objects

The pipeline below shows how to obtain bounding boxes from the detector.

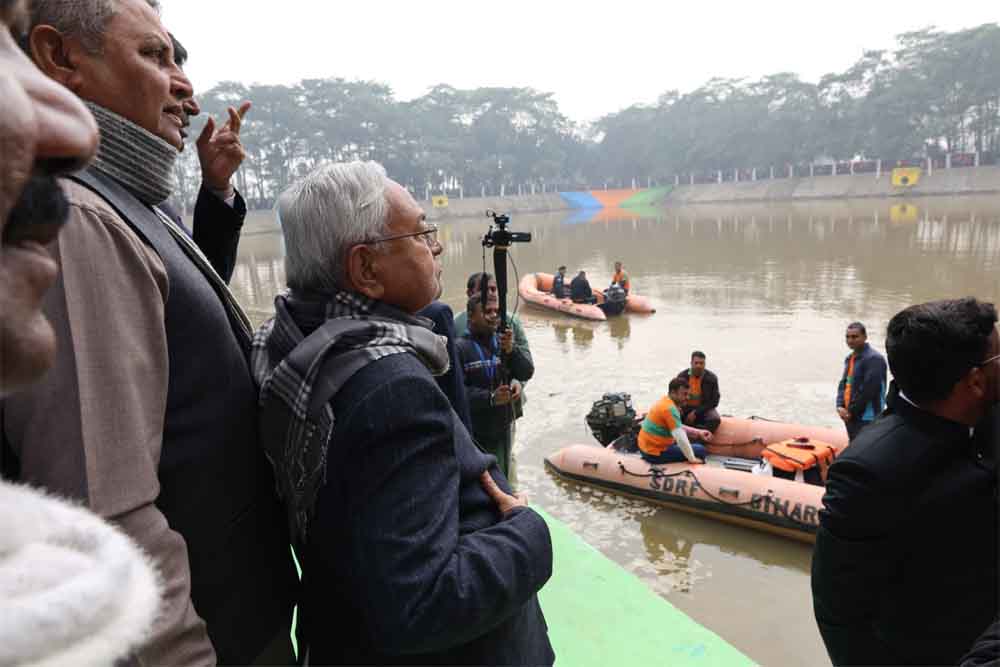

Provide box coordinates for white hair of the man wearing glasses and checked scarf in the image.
[276,162,389,291]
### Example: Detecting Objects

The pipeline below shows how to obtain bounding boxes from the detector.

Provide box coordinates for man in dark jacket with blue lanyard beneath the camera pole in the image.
[457,296,535,478]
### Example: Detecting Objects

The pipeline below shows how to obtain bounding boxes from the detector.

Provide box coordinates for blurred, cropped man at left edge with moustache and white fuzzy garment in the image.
[0,0,159,665]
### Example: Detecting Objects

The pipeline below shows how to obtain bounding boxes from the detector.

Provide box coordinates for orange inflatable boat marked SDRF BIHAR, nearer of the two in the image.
[545,417,847,542]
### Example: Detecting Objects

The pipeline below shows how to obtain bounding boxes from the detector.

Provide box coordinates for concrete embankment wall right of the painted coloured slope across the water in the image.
[666,167,1000,204]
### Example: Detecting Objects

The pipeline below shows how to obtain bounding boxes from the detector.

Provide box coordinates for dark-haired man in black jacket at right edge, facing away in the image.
[812,298,1000,665]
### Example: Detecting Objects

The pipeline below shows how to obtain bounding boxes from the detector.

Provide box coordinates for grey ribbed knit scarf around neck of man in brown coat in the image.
[85,102,177,206]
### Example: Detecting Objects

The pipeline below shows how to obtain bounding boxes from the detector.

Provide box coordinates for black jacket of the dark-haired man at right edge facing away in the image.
[812,396,998,665]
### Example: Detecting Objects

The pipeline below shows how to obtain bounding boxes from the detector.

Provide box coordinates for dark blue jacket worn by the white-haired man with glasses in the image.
[299,354,554,665]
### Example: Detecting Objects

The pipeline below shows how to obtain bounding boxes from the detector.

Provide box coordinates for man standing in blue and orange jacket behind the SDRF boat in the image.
[837,322,886,440]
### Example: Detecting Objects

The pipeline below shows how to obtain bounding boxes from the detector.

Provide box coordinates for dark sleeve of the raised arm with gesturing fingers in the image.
[157,186,247,283]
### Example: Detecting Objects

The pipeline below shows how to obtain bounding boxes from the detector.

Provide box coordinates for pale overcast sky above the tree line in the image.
[162,0,1000,121]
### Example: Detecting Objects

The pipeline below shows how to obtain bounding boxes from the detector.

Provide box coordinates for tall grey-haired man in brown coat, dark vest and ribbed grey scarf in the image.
[3,0,296,665]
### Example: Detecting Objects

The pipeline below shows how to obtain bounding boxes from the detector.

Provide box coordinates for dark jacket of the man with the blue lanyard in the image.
[456,334,535,440]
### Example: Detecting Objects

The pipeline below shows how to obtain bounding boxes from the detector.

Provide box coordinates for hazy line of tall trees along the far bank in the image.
[177,23,1000,208]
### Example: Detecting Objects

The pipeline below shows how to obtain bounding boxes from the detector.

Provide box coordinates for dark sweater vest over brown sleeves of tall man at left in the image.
[71,170,296,664]
